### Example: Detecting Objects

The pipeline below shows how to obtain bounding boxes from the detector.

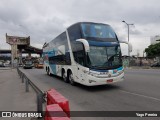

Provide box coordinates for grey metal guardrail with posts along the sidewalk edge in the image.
[17,67,46,116]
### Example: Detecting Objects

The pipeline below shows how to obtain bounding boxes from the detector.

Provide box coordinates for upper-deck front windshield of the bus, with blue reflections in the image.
[81,23,116,39]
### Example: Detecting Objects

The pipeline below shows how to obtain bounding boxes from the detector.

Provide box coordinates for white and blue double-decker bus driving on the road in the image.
[43,22,124,86]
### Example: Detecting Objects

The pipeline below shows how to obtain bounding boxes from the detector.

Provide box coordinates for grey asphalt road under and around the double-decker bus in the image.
[22,69,160,120]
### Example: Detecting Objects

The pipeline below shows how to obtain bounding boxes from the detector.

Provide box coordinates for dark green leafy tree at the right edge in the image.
[145,42,160,57]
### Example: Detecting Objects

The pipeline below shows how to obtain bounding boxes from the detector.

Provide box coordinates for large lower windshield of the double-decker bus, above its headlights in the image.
[87,46,122,69]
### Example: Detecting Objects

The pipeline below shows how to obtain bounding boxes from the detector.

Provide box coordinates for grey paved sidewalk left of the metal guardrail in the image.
[0,69,37,120]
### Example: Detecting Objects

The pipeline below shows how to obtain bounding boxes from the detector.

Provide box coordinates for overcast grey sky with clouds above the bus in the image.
[0,0,160,56]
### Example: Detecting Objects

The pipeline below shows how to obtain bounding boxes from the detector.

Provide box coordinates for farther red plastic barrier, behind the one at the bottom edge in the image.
[47,89,70,117]
